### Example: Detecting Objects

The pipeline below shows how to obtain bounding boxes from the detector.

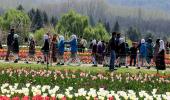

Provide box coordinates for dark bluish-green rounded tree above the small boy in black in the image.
[127,27,141,42]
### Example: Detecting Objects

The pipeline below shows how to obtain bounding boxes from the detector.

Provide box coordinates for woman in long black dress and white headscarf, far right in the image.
[156,40,166,72]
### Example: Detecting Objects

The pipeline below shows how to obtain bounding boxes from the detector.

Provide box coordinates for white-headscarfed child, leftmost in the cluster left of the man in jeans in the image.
[92,39,97,67]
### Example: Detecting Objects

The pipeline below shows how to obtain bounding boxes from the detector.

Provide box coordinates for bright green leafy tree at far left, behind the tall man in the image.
[1,9,30,37]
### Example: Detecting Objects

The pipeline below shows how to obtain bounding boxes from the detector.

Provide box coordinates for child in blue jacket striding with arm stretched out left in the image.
[65,35,81,66]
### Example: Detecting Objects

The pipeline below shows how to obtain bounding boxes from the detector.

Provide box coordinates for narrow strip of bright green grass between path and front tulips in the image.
[0,63,170,75]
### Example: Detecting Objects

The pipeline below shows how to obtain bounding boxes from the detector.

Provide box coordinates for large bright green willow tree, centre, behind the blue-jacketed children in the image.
[56,11,89,36]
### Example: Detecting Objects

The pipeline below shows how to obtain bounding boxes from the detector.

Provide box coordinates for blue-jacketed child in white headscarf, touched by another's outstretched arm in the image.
[58,35,64,65]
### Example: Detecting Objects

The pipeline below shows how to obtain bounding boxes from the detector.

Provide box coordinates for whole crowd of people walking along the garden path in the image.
[1,29,166,71]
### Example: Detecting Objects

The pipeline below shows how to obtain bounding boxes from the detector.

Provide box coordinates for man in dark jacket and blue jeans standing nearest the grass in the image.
[109,32,116,71]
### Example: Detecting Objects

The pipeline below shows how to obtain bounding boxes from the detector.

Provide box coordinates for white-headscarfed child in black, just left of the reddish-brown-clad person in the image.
[41,35,50,64]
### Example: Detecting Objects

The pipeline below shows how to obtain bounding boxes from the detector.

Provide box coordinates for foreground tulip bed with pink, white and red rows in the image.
[0,68,170,100]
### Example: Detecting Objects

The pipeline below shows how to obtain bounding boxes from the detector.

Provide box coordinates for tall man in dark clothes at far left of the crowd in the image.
[5,28,14,61]
